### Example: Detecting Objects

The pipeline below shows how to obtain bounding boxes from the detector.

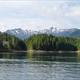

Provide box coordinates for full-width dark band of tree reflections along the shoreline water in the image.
[0,52,80,62]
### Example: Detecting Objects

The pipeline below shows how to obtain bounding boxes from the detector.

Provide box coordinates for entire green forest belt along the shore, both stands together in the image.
[0,33,80,51]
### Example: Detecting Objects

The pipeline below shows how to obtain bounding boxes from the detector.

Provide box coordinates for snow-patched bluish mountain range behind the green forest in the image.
[5,27,80,40]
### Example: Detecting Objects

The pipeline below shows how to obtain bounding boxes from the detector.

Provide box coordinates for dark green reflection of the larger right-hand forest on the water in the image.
[27,52,77,62]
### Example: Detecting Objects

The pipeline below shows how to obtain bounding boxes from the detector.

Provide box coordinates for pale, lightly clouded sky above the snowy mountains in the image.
[0,0,80,31]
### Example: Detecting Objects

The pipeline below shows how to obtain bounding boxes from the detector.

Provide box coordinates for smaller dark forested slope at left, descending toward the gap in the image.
[0,33,26,51]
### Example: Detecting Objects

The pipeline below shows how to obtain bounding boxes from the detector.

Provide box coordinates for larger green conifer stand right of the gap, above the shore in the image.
[26,34,80,51]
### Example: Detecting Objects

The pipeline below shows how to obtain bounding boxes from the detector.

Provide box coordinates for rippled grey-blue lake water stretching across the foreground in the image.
[0,53,80,80]
